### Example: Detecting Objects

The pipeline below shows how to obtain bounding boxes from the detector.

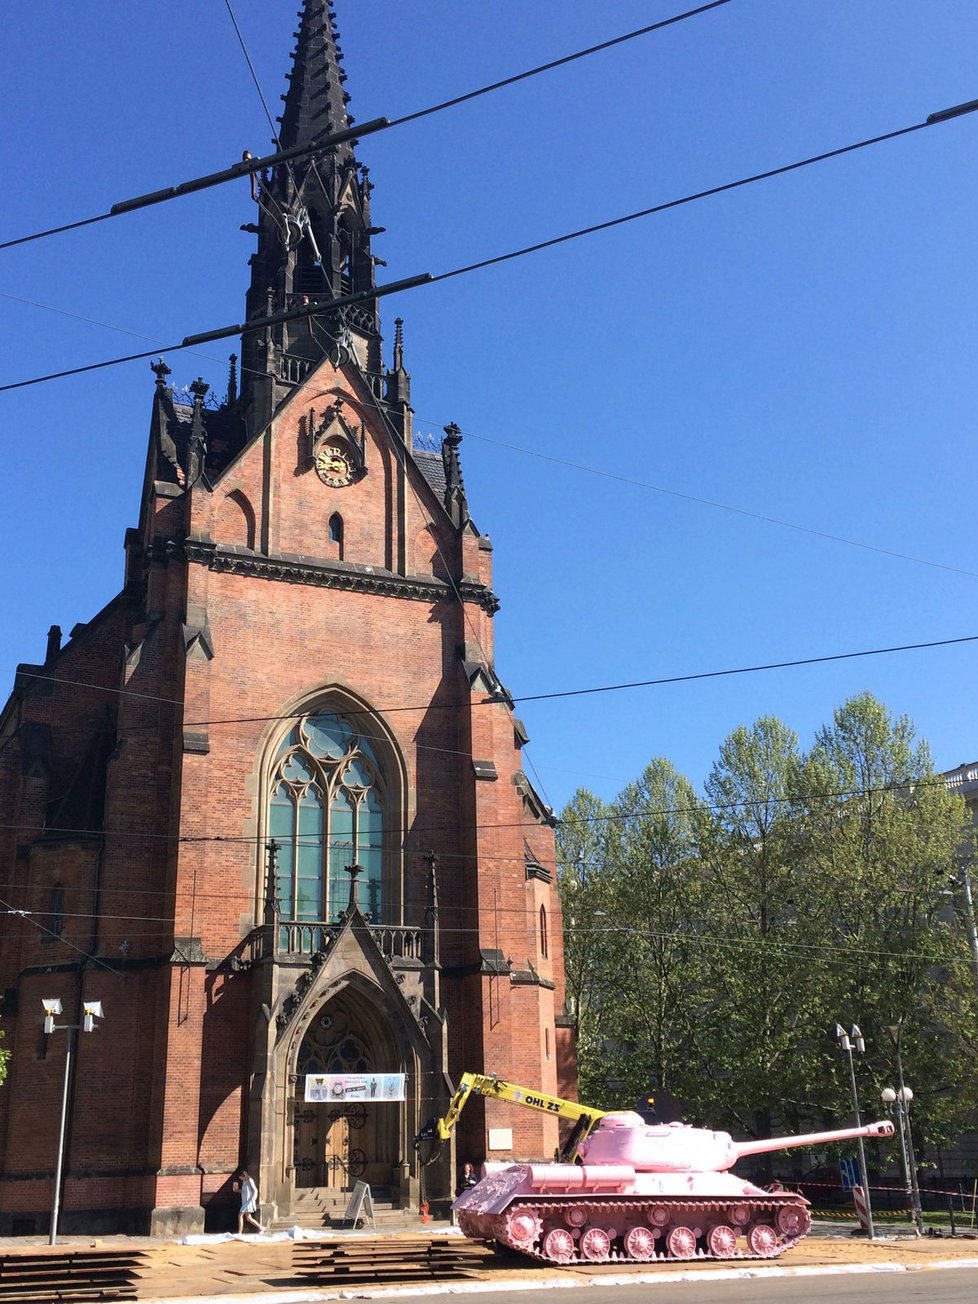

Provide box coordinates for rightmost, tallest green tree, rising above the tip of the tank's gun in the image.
[808,694,978,1148]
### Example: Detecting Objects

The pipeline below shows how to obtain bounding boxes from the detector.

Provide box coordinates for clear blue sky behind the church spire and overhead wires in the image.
[0,0,978,807]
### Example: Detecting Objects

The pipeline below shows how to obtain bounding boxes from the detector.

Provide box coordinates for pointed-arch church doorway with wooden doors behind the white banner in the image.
[292,988,402,1192]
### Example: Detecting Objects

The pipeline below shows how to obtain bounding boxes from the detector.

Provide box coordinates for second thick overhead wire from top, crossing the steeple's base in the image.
[0,99,978,394]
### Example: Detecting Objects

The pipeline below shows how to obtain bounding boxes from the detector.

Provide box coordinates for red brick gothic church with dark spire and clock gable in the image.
[0,0,574,1234]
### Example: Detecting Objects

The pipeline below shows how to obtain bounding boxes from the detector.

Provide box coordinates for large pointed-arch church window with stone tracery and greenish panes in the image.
[269,711,386,923]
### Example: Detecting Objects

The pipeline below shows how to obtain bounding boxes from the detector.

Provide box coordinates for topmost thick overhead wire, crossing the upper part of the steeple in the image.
[0,0,730,256]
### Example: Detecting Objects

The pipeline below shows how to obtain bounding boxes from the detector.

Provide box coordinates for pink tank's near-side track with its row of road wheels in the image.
[458,1194,811,1266]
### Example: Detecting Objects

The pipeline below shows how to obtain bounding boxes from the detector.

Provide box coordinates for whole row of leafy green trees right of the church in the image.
[558,694,978,1168]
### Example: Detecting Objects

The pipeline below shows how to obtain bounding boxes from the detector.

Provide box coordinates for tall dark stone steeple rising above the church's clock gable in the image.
[241,0,382,434]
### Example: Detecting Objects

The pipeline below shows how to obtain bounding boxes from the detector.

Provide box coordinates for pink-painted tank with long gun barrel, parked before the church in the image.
[454,1114,893,1264]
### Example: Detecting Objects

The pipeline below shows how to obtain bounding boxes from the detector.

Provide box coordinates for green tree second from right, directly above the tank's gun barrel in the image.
[698,717,827,1136]
